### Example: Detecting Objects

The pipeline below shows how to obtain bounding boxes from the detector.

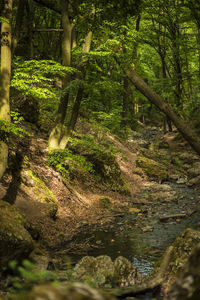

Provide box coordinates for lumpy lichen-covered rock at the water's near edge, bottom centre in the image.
[72,255,141,287]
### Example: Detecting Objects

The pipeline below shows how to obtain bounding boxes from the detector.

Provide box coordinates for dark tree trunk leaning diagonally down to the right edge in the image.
[125,69,200,155]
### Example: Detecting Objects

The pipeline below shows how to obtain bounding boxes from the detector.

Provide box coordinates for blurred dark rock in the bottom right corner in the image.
[166,244,200,300]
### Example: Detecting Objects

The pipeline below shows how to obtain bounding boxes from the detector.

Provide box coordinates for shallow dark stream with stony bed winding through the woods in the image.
[61,182,200,275]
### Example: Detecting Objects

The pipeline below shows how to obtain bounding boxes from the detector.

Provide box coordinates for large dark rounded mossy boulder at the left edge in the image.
[0,200,34,272]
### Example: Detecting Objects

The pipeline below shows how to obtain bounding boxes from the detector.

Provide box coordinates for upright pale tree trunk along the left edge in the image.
[0,0,12,179]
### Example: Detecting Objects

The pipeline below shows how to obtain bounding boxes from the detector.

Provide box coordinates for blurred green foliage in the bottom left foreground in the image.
[9,260,57,299]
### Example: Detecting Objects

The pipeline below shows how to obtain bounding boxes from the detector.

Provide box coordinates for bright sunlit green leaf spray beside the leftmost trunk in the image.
[11,57,78,100]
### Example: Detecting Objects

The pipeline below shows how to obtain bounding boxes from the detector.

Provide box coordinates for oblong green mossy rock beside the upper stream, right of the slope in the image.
[136,156,169,180]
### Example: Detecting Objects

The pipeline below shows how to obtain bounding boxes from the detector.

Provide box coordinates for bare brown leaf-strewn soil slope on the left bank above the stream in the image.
[0,122,145,248]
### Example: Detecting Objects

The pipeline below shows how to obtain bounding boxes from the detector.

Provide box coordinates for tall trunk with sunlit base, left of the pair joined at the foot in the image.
[49,0,72,150]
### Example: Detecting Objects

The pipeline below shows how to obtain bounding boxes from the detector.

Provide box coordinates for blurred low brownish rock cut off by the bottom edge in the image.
[26,283,116,300]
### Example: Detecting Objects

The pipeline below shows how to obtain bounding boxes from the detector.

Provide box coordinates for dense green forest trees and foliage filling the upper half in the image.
[0,0,200,178]
